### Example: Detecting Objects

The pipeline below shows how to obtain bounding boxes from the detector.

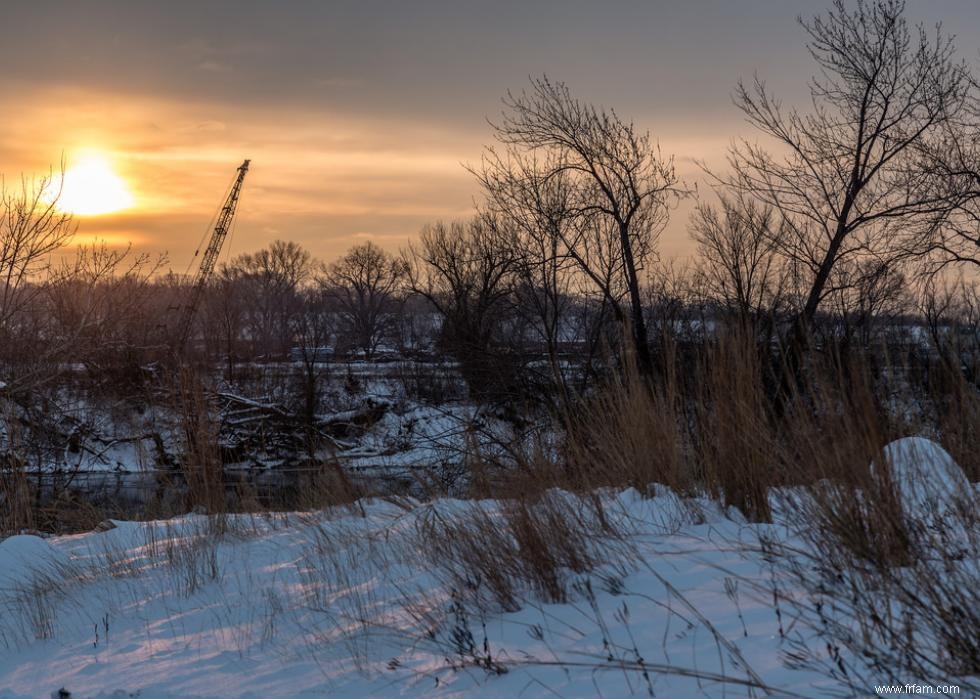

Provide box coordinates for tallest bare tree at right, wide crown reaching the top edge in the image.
[721,0,970,356]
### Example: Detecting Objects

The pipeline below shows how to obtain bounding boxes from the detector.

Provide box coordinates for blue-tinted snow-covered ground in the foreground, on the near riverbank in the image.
[0,440,976,699]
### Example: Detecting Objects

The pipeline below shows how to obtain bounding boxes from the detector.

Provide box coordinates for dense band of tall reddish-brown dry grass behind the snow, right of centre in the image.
[552,332,936,540]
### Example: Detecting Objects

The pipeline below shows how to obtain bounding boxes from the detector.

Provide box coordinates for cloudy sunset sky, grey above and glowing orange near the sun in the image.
[0,0,980,271]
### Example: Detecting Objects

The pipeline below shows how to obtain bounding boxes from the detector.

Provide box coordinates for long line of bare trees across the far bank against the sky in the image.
[0,0,980,404]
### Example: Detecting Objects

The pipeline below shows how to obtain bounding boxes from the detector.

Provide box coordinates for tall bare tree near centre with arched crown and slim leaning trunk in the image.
[477,77,681,374]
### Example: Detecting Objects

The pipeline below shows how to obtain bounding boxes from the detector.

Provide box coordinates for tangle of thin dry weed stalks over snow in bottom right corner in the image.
[764,461,980,694]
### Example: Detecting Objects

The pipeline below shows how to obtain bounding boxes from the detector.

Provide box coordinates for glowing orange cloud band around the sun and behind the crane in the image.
[0,82,480,270]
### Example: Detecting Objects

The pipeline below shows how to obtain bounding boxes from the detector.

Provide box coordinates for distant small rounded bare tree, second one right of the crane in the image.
[320,242,407,358]
